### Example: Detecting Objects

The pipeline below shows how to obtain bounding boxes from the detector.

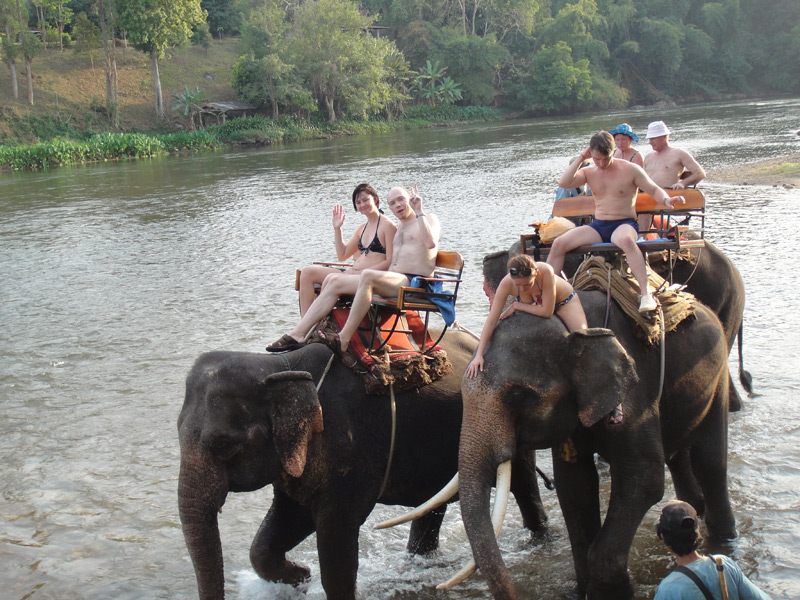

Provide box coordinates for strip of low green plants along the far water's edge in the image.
[0,105,499,170]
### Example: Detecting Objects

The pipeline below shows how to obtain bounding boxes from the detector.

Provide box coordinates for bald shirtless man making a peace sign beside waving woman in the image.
[267,184,440,351]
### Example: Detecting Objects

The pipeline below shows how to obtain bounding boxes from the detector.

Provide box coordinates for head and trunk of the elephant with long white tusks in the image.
[459,322,638,598]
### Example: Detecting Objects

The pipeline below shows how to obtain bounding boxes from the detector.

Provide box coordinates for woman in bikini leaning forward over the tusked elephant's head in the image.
[467,254,587,378]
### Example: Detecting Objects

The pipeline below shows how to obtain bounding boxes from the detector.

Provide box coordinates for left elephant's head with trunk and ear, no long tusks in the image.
[178,353,323,599]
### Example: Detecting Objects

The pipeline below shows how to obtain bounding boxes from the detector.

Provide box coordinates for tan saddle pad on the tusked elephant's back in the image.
[572,253,694,344]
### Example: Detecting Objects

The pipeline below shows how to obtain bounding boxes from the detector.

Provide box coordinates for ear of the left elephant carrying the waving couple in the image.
[264,371,323,477]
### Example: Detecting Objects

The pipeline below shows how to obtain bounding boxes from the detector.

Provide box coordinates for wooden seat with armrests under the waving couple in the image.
[367,250,464,354]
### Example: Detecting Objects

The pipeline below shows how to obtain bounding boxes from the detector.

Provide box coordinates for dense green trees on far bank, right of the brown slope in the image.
[219,0,800,119]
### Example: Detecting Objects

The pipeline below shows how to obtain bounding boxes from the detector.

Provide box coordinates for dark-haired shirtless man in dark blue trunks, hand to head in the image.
[547,131,685,313]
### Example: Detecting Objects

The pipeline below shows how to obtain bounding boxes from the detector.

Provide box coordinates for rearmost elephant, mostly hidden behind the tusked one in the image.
[483,237,753,412]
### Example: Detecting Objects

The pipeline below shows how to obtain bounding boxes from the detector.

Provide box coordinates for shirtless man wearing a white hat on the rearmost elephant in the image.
[644,121,706,190]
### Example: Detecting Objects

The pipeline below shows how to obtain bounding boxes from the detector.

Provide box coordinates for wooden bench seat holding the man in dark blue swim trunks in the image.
[520,189,706,279]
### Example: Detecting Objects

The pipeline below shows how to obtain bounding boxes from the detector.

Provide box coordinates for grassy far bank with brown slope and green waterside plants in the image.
[0,39,498,170]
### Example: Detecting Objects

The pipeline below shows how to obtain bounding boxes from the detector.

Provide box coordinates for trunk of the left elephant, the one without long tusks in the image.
[178,444,228,600]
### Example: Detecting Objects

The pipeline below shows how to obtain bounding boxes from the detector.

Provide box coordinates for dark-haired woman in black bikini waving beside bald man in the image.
[299,183,397,317]
